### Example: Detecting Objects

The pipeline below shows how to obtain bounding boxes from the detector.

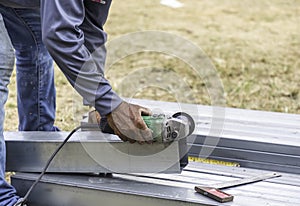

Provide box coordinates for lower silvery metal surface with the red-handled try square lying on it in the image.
[12,163,300,206]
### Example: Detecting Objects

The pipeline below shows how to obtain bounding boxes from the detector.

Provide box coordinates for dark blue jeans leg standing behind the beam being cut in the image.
[0,5,58,131]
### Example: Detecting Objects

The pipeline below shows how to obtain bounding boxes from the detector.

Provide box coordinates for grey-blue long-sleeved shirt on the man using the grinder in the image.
[0,0,123,116]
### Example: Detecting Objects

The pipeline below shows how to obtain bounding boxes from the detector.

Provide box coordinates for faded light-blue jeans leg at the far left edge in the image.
[0,15,18,206]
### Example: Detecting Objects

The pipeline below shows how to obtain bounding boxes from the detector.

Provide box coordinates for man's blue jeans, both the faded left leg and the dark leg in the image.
[0,5,58,206]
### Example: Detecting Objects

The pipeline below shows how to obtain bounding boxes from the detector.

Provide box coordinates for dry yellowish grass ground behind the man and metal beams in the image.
[5,0,300,130]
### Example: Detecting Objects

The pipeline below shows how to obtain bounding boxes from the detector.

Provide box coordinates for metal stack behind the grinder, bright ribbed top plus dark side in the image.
[128,99,300,174]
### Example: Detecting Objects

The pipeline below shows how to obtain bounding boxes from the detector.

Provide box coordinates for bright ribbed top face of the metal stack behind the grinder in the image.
[128,99,300,146]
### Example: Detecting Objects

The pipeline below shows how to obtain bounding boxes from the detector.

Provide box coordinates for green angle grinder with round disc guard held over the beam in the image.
[143,112,195,143]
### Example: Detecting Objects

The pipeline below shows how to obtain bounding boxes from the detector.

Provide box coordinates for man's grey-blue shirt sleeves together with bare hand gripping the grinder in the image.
[0,0,152,205]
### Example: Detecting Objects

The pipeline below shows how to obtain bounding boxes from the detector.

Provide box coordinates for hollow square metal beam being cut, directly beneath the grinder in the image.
[4,131,187,173]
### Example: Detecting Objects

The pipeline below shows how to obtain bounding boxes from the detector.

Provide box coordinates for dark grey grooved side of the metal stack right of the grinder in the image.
[188,135,300,174]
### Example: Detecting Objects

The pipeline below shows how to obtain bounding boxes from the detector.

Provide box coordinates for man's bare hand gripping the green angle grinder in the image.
[107,102,153,144]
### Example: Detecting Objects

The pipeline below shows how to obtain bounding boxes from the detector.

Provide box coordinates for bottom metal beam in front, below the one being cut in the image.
[12,173,218,206]
